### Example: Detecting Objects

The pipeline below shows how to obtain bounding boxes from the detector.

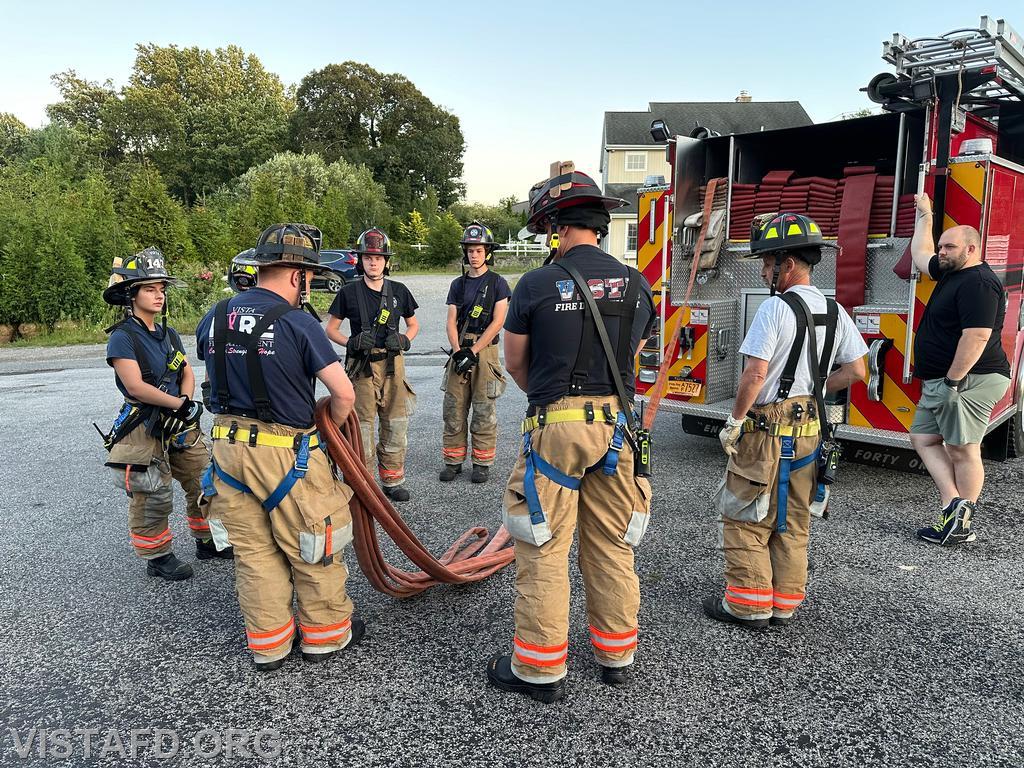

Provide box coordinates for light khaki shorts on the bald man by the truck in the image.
[910,374,1010,445]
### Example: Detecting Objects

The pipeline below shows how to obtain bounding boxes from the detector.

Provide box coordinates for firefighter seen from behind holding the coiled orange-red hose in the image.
[196,224,366,672]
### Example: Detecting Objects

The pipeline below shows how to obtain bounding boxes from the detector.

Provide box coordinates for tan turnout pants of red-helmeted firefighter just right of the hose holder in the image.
[352,349,416,486]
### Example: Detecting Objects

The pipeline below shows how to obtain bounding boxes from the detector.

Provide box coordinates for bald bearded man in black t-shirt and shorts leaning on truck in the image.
[910,195,1010,547]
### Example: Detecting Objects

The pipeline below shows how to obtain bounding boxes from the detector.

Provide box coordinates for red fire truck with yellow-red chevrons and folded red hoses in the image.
[636,16,1024,471]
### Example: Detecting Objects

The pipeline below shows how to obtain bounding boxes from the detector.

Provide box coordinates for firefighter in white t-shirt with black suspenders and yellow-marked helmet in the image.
[703,213,867,630]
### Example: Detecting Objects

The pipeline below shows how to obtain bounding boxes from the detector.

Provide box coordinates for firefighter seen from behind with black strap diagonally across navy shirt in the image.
[487,164,654,702]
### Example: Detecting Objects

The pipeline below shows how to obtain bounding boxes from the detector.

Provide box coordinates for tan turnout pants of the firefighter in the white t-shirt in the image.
[715,397,820,618]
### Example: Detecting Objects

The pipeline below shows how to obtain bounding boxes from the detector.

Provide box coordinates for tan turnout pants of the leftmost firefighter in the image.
[108,425,210,560]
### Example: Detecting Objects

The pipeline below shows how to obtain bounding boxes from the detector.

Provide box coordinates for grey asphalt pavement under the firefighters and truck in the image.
[0,276,1024,768]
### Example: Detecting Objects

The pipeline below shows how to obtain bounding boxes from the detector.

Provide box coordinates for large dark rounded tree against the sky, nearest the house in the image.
[291,61,465,211]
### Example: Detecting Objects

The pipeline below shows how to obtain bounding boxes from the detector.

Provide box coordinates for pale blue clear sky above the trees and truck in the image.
[0,0,1007,203]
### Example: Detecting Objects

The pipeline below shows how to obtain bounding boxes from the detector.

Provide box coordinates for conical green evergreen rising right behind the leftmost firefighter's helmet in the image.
[120,166,196,264]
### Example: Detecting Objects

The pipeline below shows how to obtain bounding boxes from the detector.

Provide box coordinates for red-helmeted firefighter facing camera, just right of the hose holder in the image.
[327,227,420,502]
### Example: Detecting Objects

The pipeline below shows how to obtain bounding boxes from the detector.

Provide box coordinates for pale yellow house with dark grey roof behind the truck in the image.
[600,91,812,261]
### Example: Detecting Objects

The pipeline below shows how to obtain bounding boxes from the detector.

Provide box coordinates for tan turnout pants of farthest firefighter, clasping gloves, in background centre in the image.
[441,335,507,467]
